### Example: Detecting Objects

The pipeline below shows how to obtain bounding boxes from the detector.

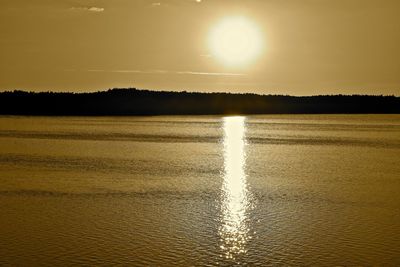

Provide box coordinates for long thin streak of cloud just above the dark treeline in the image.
[75,69,246,76]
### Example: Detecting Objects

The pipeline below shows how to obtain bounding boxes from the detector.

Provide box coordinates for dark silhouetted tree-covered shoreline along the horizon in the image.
[0,88,400,116]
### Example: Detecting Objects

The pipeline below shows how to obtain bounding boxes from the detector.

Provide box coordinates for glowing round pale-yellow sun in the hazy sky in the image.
[208,17,263,67]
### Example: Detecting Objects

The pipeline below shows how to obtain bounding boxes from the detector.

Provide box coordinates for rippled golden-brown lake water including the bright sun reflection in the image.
[0,115,400,266]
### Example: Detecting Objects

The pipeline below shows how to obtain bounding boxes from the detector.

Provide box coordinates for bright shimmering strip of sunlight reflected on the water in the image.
[220,117,250,259]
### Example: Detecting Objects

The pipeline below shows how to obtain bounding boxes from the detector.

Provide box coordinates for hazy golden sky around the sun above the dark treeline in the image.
[0,0,400,95]
